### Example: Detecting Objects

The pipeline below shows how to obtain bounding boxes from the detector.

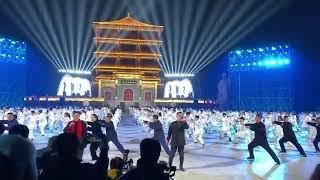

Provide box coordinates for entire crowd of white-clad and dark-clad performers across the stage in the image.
[0,107,320,170]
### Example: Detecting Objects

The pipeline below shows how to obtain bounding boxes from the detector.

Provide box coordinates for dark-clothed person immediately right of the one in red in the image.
[87,114,108,160]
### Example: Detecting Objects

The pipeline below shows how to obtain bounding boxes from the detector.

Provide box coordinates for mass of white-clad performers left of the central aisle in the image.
[0,107,122,140]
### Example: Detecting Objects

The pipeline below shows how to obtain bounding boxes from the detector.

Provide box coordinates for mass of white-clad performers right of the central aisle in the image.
[130,108,320,148]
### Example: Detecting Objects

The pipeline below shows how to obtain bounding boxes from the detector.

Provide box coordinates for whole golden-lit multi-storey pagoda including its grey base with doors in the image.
[93,14,163,106]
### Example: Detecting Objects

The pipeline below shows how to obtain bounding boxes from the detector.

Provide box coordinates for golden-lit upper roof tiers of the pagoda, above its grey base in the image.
[93,15,163,81]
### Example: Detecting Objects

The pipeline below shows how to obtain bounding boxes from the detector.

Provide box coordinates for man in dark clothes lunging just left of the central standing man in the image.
[145,114,171,156]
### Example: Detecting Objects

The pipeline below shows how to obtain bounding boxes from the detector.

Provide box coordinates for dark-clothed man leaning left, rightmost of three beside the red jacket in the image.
[101,114,129,154]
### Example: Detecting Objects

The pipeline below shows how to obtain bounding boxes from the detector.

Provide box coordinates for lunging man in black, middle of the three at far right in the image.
[274,116,307,157]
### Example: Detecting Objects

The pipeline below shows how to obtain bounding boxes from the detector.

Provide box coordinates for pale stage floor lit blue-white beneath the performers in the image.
[34,117,320,180]
